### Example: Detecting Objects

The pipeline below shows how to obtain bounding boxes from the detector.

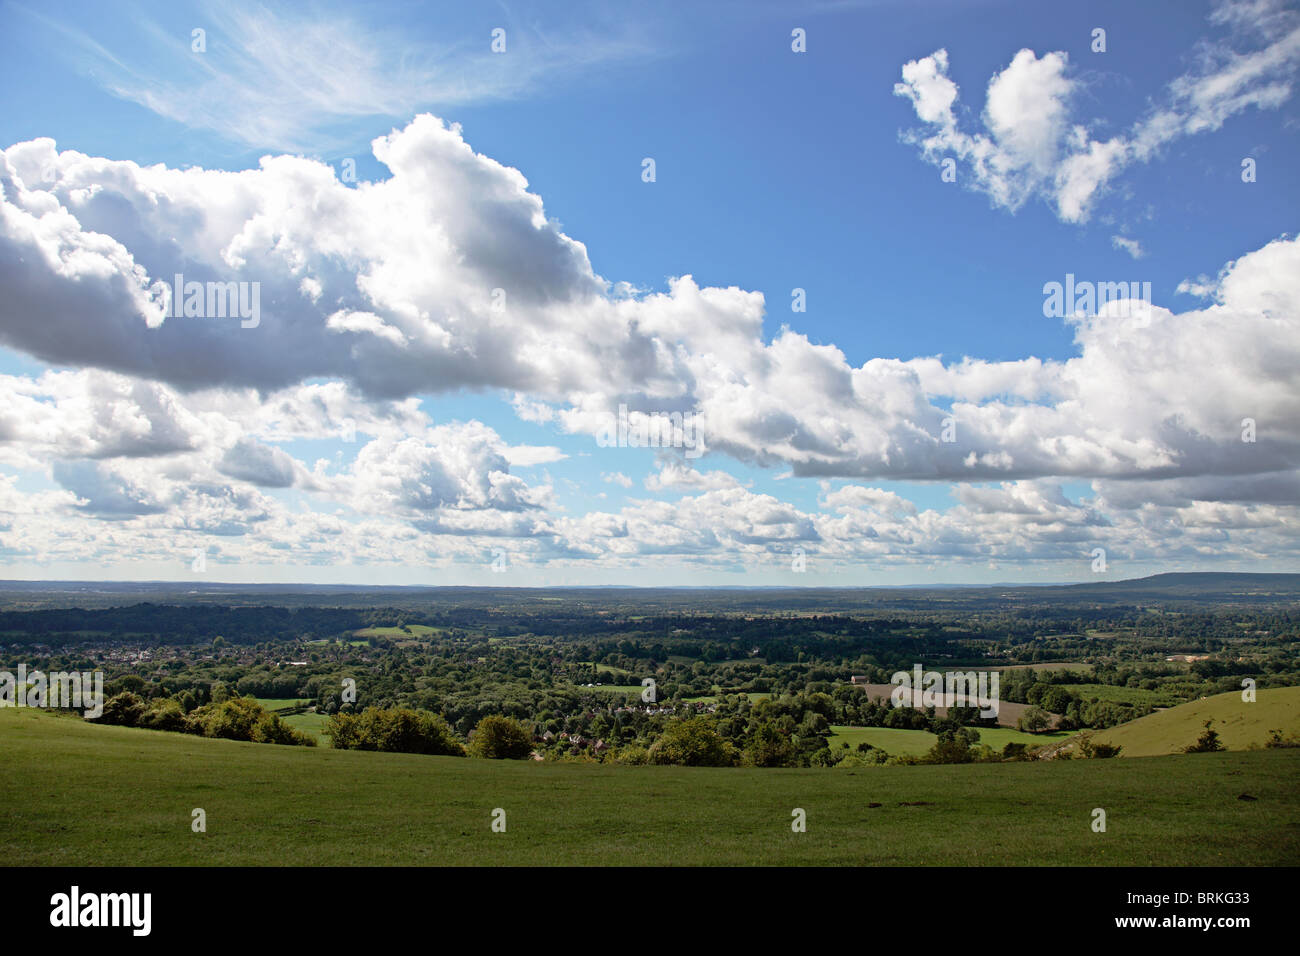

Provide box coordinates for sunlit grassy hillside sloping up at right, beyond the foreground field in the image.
[1096,687,1300,757]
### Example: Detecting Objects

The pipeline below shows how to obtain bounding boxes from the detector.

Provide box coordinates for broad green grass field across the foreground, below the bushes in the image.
[0,709,1300,866]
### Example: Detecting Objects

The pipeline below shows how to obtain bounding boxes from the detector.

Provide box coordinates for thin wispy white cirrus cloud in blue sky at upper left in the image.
[27,3,655,152]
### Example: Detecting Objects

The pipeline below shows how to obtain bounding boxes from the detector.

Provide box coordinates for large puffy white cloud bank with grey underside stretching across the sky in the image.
[0,113,1300,485]
